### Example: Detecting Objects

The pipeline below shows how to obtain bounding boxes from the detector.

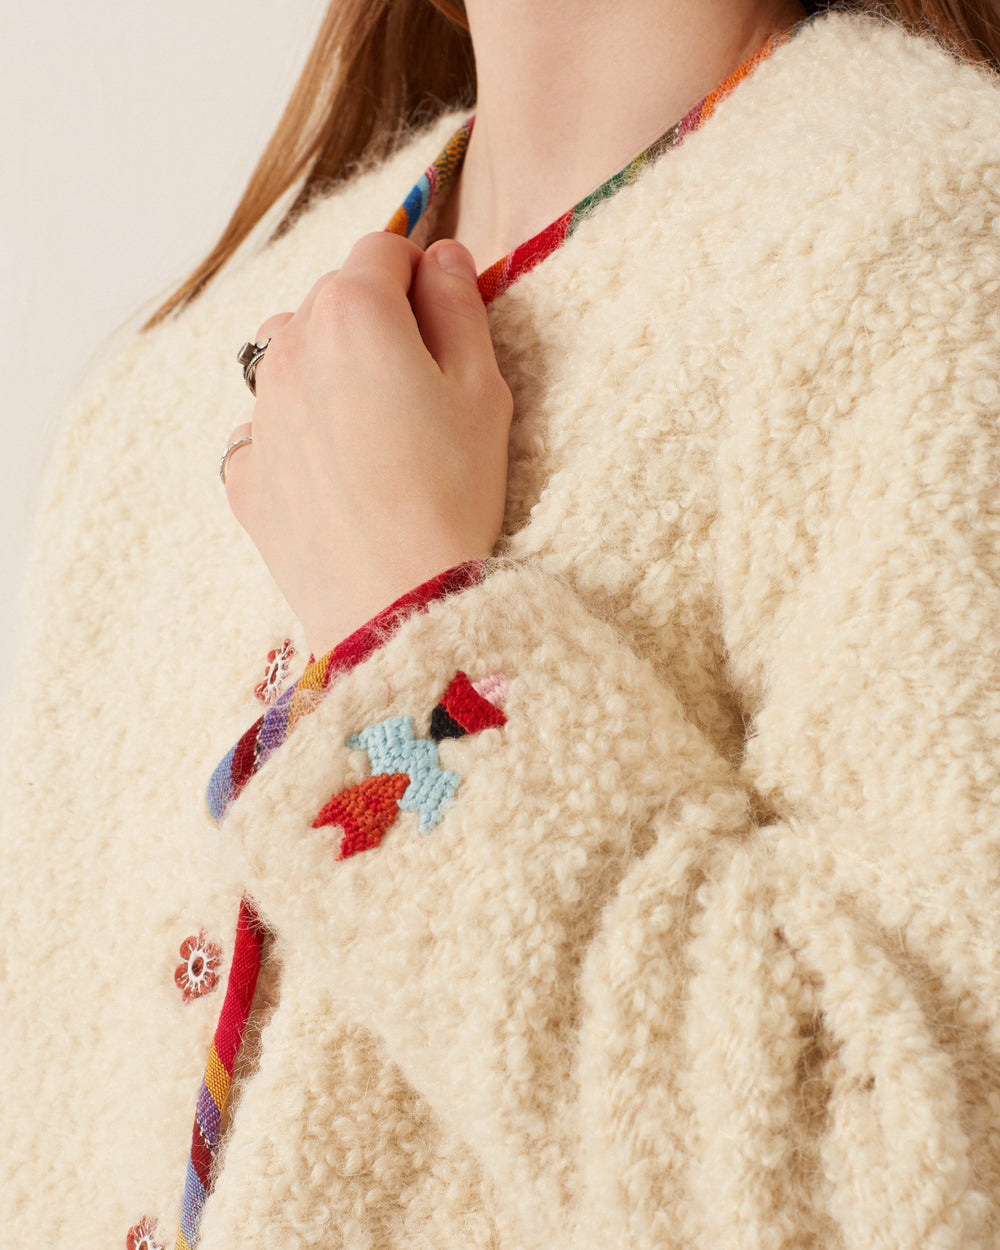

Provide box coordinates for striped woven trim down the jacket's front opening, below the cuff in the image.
[175,899,265,1250]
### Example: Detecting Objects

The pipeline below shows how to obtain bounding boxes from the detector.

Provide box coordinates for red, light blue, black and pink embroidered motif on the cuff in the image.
[313,673,508,860]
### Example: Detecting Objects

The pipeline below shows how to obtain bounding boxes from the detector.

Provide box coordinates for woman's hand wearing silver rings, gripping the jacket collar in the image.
[226,234,513,656]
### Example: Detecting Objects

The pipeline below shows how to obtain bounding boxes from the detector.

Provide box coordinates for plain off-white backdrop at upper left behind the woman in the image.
[0,0,326,701]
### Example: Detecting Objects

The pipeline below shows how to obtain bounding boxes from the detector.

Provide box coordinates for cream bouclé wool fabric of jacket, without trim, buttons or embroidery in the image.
[0,16,1000,1250]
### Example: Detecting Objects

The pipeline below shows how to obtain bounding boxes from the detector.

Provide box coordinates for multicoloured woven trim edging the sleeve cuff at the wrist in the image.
[206,560,486,821]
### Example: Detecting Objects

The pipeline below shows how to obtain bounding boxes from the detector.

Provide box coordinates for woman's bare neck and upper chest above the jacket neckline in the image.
[435,0,805,270]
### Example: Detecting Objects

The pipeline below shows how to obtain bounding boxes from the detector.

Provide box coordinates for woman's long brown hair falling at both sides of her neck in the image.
[145,0,1000,329]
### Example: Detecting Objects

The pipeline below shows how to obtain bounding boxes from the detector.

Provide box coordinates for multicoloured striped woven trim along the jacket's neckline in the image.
[385,16,813,304]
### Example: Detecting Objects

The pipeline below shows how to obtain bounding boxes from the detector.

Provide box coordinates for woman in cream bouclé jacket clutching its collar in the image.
[4,0,1000,1250]
